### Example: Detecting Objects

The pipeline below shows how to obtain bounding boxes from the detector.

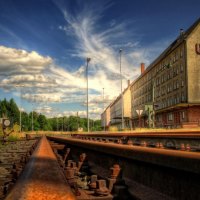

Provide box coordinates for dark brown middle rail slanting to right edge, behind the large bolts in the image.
[48,136,200,174]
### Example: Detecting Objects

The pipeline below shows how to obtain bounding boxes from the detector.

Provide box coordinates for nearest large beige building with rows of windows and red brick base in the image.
[131,19,200,127]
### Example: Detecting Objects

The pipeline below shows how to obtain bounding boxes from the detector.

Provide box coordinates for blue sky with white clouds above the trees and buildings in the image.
[0,0,200,119]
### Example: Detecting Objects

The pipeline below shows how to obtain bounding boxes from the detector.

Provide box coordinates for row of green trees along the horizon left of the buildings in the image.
[0,99,101,131]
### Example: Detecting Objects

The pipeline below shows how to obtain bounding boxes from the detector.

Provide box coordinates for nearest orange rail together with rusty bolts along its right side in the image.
[5,137,113,200]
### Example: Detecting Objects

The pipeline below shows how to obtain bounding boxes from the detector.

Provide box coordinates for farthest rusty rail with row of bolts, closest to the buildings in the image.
[71,131,200,152]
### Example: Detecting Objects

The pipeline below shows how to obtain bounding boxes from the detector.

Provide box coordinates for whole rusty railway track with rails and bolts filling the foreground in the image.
[2,134,200,200]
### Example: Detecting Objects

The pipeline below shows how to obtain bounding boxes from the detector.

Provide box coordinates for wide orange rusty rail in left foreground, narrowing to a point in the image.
[5,137,76,200]
